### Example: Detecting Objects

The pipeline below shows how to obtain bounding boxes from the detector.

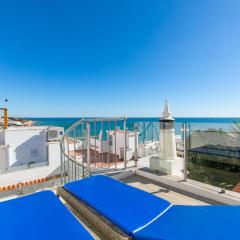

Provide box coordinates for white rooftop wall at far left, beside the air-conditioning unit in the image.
[0,126,62,186]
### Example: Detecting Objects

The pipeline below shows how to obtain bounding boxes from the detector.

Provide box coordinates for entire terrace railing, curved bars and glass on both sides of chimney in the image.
[61,117,240,194]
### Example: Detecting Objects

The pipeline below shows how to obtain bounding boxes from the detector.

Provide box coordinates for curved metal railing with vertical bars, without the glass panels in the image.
[60,117,133,183]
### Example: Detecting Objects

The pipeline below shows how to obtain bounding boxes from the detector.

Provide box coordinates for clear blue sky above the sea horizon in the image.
[0,0,240,117]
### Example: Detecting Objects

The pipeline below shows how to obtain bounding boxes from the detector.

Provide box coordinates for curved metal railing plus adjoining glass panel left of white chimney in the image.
[60,117,186,183]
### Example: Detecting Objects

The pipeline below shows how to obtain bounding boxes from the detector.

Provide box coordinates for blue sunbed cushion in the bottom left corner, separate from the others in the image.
[0,191,93,240]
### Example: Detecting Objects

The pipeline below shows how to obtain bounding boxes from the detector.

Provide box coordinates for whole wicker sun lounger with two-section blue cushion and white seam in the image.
[58,176,240,240]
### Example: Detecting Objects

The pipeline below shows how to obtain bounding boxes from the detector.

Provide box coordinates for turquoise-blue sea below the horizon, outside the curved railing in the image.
[25,117,240,135]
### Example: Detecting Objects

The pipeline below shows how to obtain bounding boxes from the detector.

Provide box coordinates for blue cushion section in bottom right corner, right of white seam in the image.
[134,206,240,240]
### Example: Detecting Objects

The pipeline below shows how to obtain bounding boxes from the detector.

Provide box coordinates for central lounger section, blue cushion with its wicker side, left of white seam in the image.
[57,176,171,239]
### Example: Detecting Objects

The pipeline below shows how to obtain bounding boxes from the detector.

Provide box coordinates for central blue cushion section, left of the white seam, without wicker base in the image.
[64,175,170,235]
